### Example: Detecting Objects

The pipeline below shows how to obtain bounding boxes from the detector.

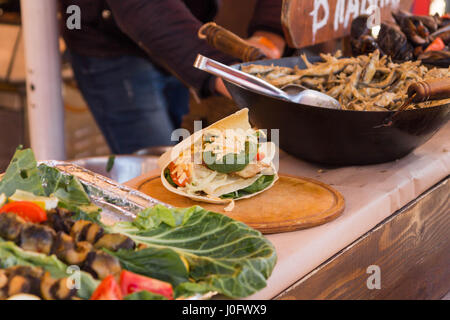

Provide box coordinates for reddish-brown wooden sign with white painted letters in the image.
[281,0,413,48]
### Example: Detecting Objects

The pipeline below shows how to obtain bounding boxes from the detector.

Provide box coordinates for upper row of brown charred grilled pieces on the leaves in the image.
[0,209,135,279]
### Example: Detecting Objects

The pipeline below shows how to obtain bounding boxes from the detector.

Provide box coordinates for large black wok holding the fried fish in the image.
[225,57,450,165]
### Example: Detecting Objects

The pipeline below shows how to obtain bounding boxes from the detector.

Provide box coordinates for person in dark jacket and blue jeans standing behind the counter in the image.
[60,0,285,154]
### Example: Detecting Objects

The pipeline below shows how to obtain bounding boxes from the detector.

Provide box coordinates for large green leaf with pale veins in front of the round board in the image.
[111,206,276,298]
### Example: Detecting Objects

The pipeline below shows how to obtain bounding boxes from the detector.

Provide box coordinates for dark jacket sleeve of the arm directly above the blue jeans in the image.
[107,0,235,96]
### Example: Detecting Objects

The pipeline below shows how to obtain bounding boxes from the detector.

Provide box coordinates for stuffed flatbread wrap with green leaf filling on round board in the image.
[158,109,278,204]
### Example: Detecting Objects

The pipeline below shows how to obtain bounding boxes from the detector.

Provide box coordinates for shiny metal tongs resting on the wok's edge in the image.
[194,54,341,109]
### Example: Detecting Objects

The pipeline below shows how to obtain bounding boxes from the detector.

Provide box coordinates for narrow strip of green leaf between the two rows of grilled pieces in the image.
[0,238,100,299]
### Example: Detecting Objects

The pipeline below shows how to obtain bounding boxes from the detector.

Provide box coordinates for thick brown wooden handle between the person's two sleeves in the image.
[198,22,266,61]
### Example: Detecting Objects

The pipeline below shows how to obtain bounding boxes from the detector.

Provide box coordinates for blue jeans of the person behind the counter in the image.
[70,52,189,154]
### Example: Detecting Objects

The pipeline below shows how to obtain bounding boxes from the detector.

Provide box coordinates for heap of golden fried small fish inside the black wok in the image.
[242,50,450,111]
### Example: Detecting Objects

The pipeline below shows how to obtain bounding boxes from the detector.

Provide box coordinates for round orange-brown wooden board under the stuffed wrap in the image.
[125,171,345,234]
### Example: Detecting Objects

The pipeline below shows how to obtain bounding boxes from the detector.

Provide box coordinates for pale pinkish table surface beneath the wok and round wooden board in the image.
[248,123,450,299]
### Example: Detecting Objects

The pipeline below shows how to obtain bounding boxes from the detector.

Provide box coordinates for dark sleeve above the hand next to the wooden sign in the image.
[248,0,284,37]
